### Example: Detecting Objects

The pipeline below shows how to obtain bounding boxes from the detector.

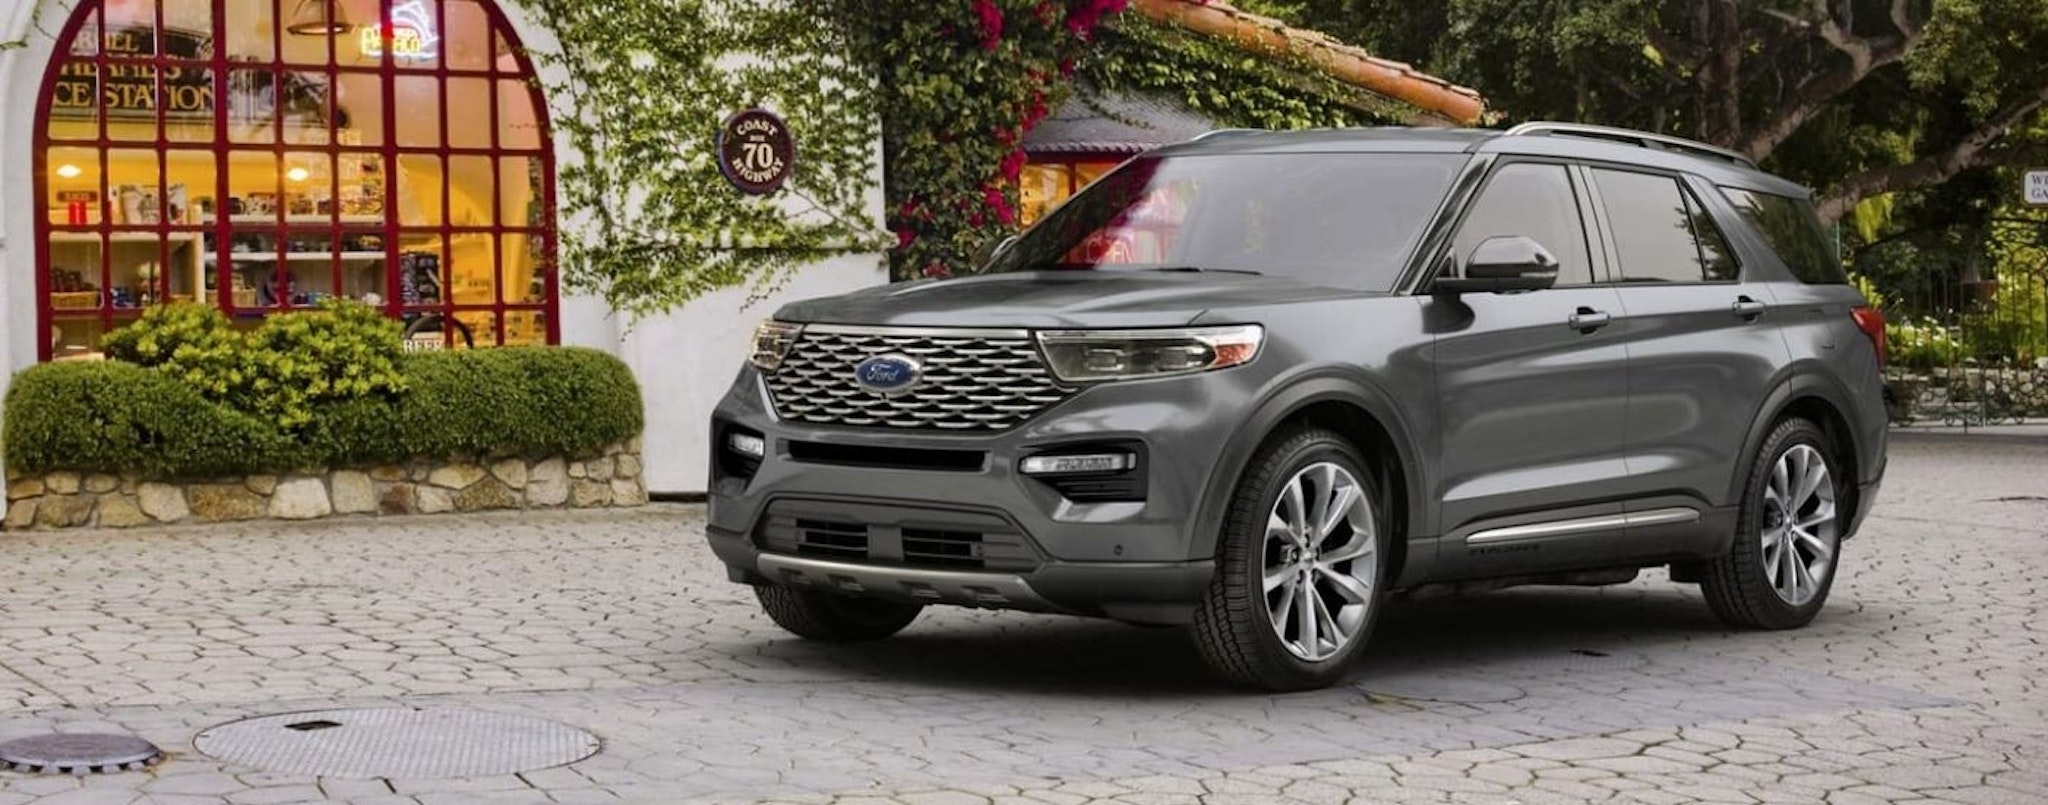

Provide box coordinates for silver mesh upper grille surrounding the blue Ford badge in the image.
[768,326,1073,430]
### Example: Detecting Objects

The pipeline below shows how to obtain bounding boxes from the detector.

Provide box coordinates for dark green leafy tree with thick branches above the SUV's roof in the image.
[1264,0,2048,221]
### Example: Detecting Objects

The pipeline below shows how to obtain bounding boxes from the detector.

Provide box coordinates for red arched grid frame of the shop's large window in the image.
[33,0,561,361]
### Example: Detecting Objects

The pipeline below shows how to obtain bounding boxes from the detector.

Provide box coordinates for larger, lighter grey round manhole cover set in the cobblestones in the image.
[193,707,600,780]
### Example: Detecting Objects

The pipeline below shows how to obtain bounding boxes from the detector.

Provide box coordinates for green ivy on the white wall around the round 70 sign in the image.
[518,0,887,313]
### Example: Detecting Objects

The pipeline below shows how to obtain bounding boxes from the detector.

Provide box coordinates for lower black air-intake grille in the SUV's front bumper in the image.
[758,500,1038,571]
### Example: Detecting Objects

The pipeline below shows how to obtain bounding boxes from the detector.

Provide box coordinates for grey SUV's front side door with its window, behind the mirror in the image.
[1425,162,1628,576]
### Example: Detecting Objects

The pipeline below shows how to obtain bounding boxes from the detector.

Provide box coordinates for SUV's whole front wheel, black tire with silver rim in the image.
[1192,428,1386,690]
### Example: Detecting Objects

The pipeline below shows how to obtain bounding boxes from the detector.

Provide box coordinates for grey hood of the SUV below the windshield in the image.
[776,270,1364,328]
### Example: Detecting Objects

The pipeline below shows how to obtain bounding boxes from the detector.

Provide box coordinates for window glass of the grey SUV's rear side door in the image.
[1593,170,1706,283]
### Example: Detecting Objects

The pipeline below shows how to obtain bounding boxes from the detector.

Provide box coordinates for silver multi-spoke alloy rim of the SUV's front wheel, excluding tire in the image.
[1262,461,1378,662]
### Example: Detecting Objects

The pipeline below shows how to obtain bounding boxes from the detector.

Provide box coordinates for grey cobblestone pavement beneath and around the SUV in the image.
[0,438,2048,805]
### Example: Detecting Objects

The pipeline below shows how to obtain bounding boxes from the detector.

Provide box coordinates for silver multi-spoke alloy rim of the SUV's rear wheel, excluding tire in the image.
[1759,444,1841,606]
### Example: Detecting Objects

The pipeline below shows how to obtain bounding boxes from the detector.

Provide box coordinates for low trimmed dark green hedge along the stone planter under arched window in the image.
[0,346,645,479]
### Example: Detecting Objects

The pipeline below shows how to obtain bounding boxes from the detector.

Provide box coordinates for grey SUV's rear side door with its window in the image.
[1585,168,1788,557]
